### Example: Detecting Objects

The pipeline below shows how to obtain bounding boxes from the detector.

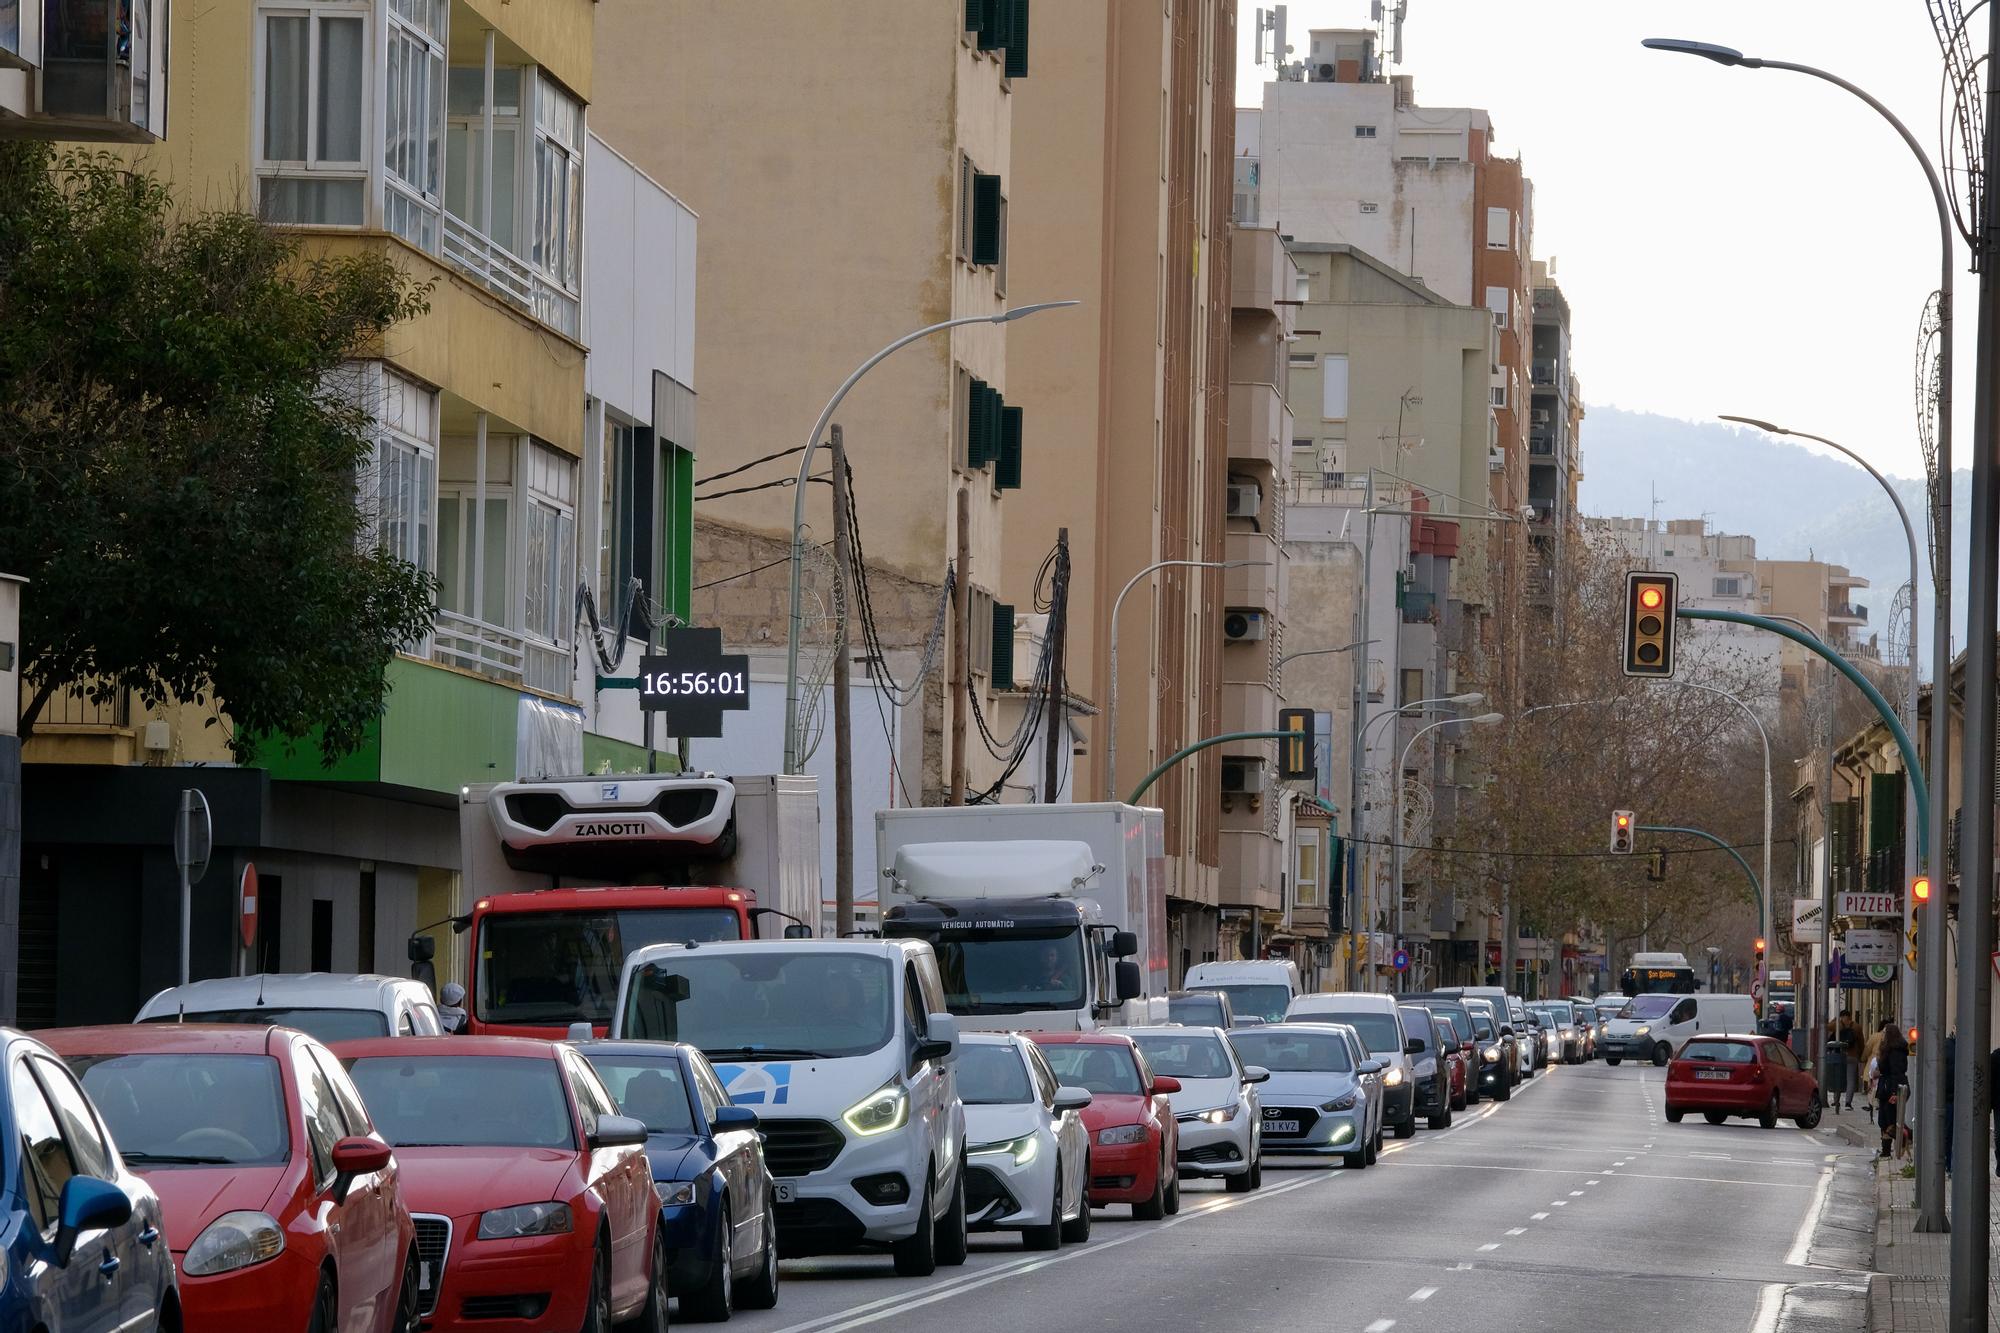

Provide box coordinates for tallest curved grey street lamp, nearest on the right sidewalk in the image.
[1644,33,1960,1232]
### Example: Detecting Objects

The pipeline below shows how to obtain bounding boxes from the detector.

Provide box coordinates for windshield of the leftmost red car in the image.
[70,1053,292,1169]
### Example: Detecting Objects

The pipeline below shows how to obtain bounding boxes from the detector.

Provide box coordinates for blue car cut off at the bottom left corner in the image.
[0,1029,180,1333]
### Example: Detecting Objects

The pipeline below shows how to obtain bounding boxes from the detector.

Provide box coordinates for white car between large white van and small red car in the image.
[958,1033,1090,1249]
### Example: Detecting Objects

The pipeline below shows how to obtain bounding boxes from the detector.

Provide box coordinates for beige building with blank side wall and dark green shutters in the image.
[592,0,1040,808]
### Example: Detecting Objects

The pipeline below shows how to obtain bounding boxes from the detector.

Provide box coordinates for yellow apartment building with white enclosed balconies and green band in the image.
[20,0,712,1023]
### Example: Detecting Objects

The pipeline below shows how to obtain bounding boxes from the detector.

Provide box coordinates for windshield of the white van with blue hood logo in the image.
[620,943,900,1061]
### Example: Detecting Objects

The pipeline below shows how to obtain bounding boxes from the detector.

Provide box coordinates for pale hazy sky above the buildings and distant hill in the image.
[1236,0,1984,476]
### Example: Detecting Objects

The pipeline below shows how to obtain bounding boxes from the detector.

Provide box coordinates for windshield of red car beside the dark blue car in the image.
[348,1055,576,1149]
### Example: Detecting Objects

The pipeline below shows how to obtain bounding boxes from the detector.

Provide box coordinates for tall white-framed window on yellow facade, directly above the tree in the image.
[258,2,368,226]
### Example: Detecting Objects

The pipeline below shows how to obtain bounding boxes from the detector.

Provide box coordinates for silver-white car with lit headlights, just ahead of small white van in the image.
[1230,1023,1382,1169]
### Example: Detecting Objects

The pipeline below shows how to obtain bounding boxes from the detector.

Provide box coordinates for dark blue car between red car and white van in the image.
[576,1041,778,1319]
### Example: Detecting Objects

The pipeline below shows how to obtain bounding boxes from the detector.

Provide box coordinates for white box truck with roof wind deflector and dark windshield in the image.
[876,801,1168,1031]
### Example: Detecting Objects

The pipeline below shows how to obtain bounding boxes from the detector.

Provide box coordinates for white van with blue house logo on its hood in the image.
[610,939,966,1277]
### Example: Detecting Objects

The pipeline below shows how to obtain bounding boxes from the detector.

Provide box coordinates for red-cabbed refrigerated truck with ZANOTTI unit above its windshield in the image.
[410,773,820,1037]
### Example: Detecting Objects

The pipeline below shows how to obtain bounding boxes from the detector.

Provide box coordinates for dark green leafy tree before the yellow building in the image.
[0,144,434,763]
